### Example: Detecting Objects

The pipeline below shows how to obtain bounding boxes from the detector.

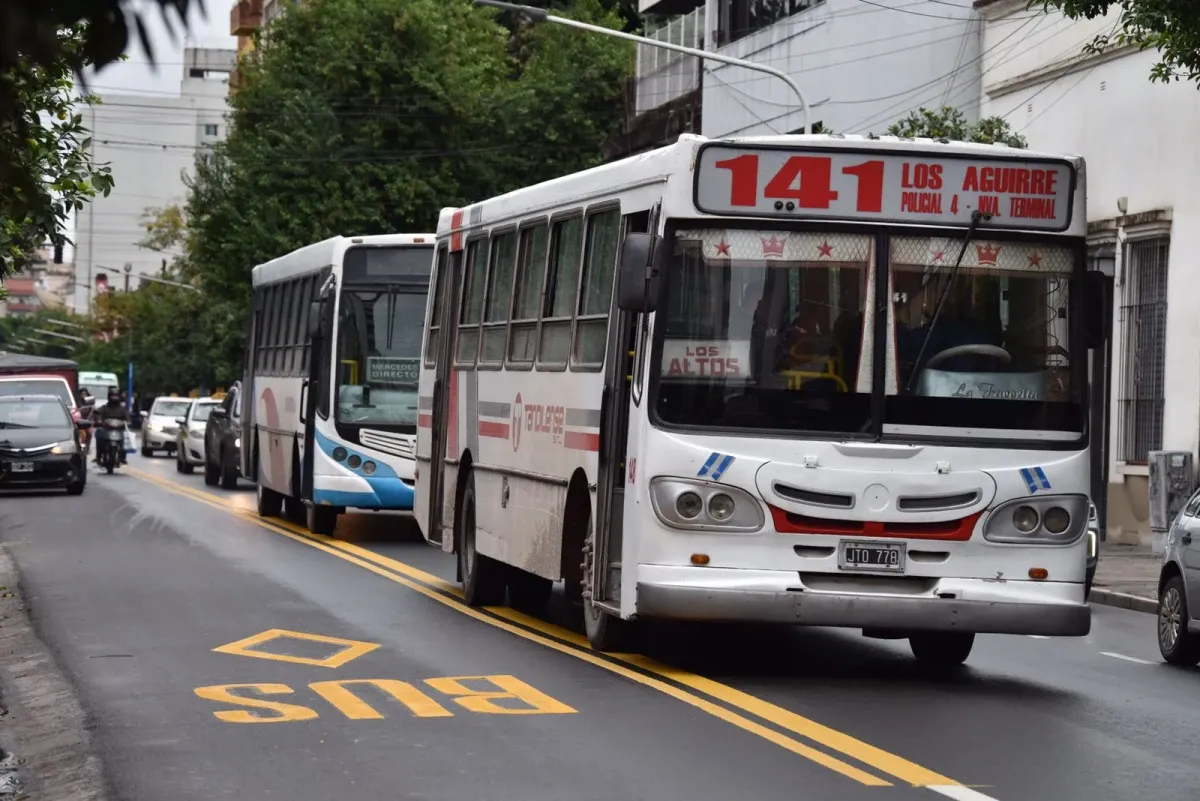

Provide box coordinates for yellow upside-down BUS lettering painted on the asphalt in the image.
[192,675,577,723]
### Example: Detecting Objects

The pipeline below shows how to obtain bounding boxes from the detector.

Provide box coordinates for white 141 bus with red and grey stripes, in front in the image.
[415,135,1106,664]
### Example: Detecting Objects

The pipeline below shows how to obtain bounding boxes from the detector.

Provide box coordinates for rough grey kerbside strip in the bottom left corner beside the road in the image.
[0,546,109,801]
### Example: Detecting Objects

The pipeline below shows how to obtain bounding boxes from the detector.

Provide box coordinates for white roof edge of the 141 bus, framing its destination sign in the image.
[437,133,1086,237]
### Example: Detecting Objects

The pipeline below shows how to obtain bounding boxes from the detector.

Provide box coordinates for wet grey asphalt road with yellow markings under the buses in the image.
[0,457,1200,801]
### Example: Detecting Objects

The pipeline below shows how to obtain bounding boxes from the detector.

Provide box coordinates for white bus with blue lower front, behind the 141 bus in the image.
[241,234,433,534]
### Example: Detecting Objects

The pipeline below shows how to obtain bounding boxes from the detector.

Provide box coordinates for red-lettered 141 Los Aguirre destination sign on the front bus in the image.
[695,144,1074,231]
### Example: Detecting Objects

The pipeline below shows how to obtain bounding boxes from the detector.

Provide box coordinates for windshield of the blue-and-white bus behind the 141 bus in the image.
[337,287,426,427]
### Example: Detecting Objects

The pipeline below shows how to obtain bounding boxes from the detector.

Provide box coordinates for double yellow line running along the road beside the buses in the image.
[125,466,992,801]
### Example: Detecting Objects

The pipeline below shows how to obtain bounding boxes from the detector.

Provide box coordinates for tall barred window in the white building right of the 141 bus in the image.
[1117,236,1171,464]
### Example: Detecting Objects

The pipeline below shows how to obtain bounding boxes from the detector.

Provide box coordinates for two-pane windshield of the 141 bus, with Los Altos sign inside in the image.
[654,229,1082,439]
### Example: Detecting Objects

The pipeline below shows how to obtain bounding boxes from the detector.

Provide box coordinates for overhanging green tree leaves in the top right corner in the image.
[1030,0,1200,86]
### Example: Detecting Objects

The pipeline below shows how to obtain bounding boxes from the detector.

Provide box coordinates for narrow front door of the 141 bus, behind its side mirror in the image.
[592,206,658,604]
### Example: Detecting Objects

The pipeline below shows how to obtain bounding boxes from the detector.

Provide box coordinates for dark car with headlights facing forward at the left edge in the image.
[0,395,91,495]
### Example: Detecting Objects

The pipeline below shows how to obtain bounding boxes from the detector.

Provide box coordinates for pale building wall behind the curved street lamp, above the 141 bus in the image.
[636,0,980,137]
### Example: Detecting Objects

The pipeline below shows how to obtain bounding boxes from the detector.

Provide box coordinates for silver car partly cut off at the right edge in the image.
[1158,489,1200,666]
